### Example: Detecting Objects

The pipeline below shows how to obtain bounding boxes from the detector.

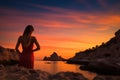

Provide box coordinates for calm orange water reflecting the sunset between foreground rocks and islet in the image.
[34,60,96,80]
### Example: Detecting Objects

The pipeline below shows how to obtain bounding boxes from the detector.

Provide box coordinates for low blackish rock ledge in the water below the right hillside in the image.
[80,59,120,75]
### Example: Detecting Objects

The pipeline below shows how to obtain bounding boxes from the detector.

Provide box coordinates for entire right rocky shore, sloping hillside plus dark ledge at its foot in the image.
[67,29,120,76]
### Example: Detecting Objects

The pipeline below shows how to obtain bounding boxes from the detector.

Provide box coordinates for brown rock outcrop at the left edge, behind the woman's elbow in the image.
[0,46,19,65]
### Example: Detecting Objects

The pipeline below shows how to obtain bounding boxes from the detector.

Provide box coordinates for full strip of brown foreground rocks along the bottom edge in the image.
[0,65,88,80]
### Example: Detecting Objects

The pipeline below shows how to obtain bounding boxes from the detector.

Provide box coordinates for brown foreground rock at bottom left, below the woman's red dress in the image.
[0,66,50,80]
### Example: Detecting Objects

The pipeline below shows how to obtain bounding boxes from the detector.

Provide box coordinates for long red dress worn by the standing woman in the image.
[19,43,34,69]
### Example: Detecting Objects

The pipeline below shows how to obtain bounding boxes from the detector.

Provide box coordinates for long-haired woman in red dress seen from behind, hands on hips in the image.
[15,25,40,68]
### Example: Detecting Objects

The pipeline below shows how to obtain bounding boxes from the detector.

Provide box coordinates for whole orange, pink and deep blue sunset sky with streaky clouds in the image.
[0,0,120,59]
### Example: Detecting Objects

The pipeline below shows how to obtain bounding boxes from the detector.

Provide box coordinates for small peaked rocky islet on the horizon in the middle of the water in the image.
[43,52,66,61]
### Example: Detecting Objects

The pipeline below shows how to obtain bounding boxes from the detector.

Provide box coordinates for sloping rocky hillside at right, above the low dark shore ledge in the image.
[68,29,120,63]
